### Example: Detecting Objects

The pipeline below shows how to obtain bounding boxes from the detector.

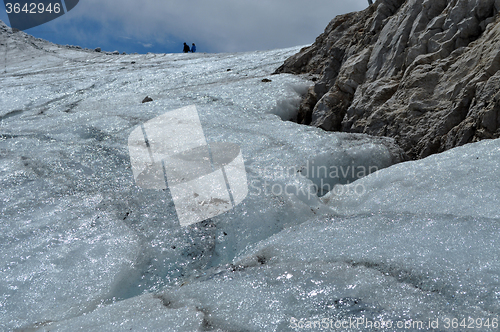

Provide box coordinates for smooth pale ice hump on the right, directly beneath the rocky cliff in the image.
[323,140,500,219]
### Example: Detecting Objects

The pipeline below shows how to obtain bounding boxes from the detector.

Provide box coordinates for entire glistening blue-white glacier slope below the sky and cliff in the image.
[0,19,500,331]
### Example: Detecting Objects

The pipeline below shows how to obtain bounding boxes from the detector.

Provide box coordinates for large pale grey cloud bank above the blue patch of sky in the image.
[75,0,368,52]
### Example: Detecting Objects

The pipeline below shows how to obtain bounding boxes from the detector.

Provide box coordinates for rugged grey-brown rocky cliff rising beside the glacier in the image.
[277,0,500,158]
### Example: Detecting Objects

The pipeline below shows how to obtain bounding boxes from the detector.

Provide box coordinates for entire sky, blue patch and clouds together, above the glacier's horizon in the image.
[0,0,368,53]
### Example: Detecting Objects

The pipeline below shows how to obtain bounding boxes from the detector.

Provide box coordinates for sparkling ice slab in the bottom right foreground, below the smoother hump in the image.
[152,214,500,331]
